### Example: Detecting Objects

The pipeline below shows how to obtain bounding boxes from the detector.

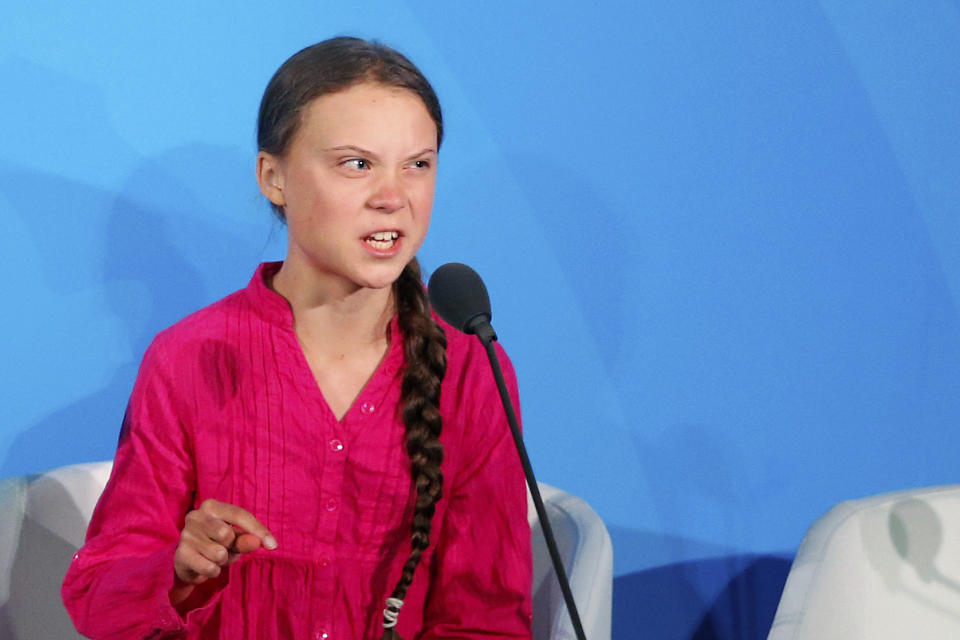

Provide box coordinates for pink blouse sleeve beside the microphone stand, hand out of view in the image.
[422,345,533,640]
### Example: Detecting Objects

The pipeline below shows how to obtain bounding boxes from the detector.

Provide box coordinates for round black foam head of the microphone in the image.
[427,262,492,333]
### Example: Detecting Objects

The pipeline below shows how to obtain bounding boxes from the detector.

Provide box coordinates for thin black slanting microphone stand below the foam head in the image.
[466,316,586,640]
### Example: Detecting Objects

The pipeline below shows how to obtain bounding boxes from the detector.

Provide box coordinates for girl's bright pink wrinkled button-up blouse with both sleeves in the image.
[63,263,531,640]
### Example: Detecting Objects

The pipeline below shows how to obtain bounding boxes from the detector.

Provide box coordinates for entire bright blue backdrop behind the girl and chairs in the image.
[0,0,960,640]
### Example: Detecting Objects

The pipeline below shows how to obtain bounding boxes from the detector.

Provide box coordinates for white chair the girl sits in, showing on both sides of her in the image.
[0,462,613,640]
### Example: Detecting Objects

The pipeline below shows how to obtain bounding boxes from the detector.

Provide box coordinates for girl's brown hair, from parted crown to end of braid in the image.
[257,37,447,640]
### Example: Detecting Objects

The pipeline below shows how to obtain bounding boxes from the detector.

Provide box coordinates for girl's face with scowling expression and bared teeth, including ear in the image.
[257,83,437,290]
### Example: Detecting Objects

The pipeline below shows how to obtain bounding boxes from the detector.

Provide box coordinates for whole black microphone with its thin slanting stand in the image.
[427,262,585,640]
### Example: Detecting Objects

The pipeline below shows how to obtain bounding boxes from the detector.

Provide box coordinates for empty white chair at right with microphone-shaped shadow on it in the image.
[769,485,960,640]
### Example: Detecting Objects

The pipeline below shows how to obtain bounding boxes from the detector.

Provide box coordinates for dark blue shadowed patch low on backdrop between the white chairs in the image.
[613,555,792,640]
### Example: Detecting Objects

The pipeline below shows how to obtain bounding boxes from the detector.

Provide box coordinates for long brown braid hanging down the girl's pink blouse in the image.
[381,258,447,640]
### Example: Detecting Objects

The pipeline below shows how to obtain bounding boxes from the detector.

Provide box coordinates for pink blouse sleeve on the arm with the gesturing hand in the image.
[61,341,223,639]
